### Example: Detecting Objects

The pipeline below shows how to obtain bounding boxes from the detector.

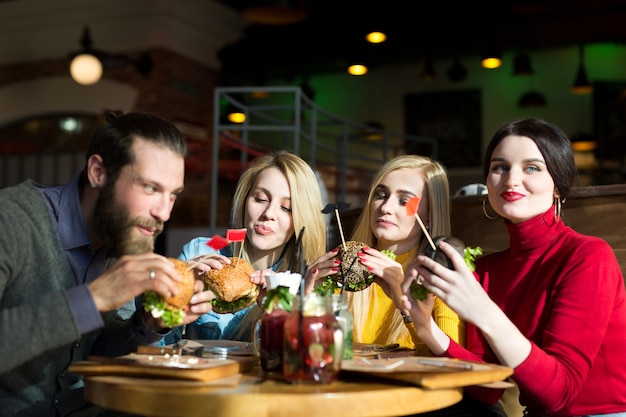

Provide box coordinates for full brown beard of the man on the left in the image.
[94,184,163,258]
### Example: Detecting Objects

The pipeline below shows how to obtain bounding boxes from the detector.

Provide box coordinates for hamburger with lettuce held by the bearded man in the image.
[143,258,195,327]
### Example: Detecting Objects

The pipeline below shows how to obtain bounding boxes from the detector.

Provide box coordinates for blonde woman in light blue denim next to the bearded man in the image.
[166,150,326,343]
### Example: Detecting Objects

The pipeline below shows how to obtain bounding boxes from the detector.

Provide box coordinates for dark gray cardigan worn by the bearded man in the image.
[0,181,139,417]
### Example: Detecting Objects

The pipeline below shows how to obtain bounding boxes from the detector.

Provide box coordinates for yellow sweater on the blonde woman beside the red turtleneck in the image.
[350,249,465,355]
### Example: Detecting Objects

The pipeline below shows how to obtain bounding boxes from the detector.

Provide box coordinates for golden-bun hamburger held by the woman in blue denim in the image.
[200,257,259,314]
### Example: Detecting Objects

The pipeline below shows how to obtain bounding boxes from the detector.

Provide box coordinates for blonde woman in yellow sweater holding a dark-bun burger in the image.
[312,155,465,355]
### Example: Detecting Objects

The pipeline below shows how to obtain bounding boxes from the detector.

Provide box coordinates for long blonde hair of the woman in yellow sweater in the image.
[347,155,450,341]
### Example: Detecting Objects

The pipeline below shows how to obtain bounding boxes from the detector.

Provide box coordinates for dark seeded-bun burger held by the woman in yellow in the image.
[332,240,374,291]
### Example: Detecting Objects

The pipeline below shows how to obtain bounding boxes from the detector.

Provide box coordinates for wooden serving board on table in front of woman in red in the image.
[341,356,513,389]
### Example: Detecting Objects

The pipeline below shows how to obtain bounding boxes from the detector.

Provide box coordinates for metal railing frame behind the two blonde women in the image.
[210,87,438,230]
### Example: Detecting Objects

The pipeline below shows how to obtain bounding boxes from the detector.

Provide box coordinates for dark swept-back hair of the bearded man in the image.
[85,109,187,182]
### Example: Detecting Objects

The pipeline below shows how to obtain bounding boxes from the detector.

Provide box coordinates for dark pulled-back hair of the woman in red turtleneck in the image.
[483,118,578,199]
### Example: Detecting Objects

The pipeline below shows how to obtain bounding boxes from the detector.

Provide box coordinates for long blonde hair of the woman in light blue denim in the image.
[230,150,326,271]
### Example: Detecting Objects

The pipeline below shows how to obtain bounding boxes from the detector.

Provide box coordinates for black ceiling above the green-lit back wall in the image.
[213,0,626,85]
